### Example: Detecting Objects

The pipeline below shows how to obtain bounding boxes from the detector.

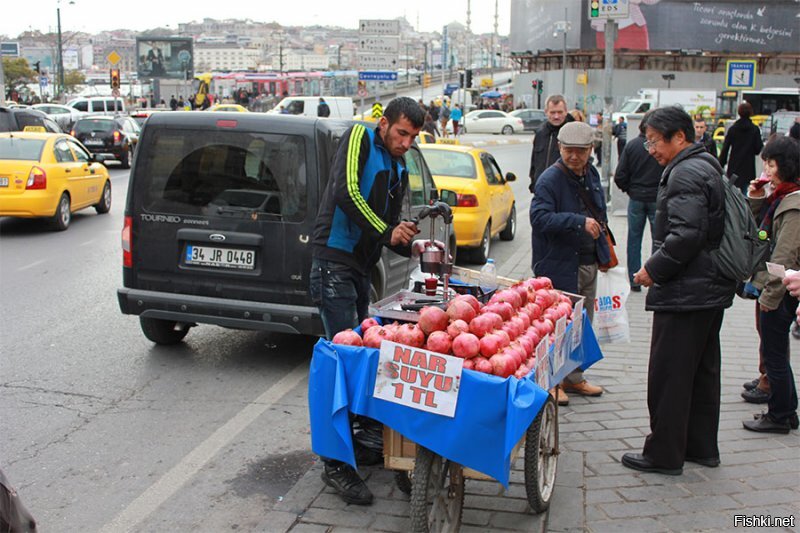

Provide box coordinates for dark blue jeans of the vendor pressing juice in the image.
[309,258,383,465]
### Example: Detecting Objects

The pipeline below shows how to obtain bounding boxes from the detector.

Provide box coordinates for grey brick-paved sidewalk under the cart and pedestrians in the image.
[259,212,800,533]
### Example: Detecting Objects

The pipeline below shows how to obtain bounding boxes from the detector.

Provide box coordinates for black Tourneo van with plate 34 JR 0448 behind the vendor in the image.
[117,112,455,344]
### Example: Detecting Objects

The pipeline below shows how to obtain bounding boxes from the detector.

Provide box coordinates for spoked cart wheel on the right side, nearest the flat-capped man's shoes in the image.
[525,395,558,514]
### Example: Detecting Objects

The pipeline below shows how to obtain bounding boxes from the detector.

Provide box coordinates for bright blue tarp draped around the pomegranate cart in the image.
[308,314,603,487]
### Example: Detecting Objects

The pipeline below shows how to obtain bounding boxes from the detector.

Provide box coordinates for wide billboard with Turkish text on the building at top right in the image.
[511,0,800,53]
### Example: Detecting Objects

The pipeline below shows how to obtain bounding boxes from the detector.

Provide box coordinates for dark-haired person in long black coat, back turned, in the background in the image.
[719,102,764,194]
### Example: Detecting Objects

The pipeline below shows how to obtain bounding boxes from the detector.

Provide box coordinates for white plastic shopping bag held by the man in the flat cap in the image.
[592,267,631,343]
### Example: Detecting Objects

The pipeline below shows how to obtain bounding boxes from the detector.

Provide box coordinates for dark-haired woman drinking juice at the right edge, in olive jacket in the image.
[743,137,800,433]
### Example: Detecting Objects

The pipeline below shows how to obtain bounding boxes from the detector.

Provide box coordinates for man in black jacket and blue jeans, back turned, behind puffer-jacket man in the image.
[614,114,664,292]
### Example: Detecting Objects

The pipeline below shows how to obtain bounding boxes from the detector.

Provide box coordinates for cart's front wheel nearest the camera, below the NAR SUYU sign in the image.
[411,446,464,533]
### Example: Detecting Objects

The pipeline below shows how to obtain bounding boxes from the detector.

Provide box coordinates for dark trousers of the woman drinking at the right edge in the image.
[760,292,797,422]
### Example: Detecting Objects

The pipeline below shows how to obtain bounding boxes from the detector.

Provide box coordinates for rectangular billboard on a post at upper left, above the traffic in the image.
[136,37,194,79]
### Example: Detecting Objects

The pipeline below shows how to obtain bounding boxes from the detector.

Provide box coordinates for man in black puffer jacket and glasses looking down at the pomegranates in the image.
[622,107,735,475]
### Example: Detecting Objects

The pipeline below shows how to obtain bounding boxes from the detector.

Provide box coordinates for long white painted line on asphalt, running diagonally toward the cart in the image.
[100,362,308,533]
